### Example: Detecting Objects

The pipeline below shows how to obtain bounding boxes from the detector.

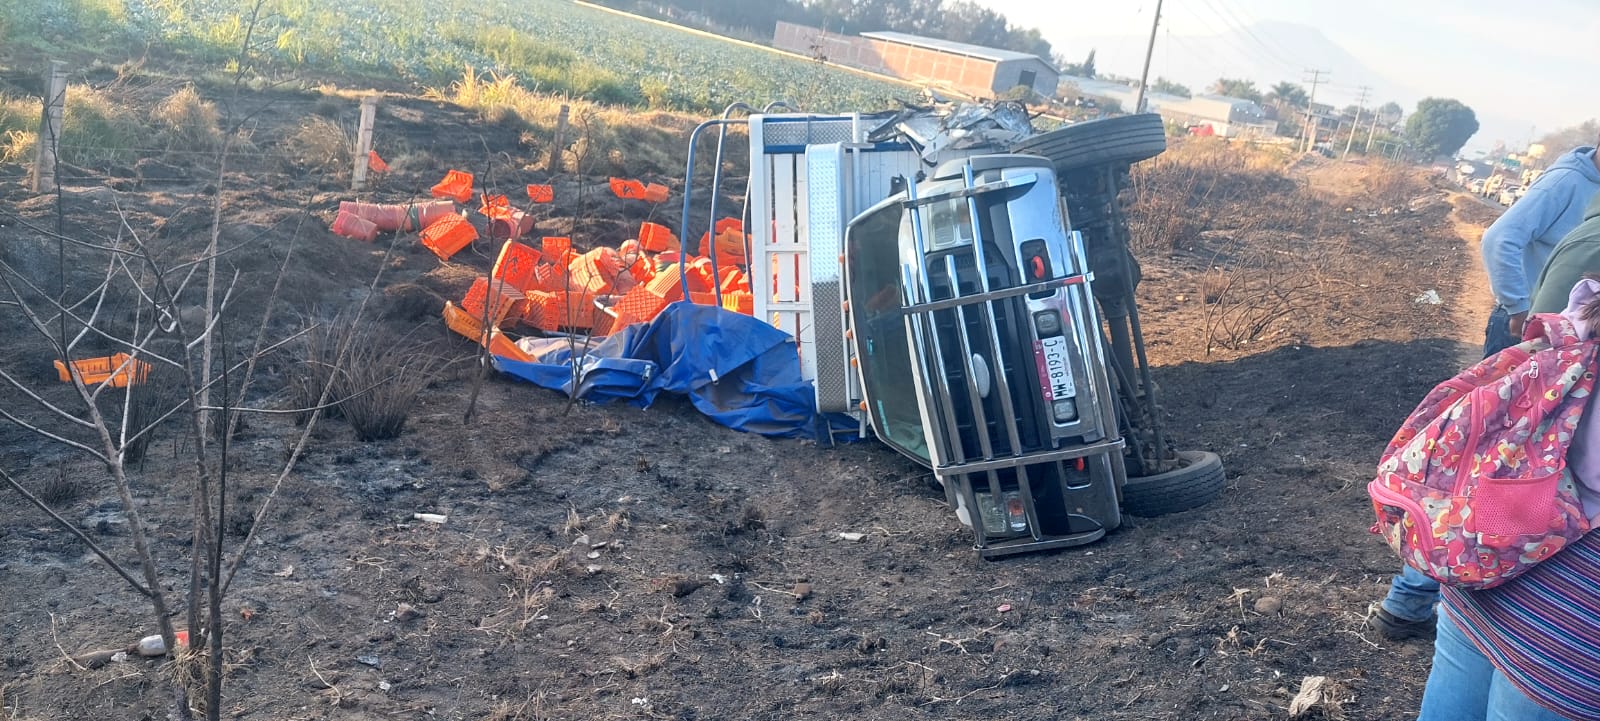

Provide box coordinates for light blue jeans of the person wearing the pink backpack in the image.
[1416,611,1565,721]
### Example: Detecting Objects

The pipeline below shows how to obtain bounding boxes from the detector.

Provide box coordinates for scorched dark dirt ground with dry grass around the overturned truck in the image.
[0,76,1493,721]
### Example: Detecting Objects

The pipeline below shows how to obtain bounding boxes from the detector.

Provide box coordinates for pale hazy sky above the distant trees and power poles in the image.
[978,0,1600,149]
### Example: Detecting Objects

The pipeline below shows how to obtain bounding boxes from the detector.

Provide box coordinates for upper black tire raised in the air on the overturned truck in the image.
[1013,112,1166,173]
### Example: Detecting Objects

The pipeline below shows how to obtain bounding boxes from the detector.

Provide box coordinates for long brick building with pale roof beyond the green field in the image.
[773,22,1061,98]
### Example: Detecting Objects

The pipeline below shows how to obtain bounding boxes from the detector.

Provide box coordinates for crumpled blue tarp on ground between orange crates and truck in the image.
[494,302,818,436]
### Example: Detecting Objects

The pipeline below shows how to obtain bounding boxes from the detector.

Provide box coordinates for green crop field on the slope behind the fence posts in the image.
[0,0,915,112]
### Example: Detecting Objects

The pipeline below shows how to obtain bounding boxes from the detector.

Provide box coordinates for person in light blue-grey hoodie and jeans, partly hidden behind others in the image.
[1366,142,1600,641]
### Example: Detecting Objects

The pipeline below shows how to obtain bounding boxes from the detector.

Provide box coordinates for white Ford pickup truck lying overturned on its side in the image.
[685,114,1222,556]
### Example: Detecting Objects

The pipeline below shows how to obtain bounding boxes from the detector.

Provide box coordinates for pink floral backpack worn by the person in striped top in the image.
[1366,313,1600,588]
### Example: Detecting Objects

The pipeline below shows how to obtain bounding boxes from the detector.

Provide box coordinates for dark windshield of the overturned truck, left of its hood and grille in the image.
[845,203,931,464]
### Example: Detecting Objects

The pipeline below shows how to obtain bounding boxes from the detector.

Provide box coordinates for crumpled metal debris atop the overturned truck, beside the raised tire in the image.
[867,101,1034,163]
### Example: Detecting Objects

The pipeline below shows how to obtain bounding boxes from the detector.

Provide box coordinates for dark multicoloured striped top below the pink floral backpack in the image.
[1443,532,1600,721]
